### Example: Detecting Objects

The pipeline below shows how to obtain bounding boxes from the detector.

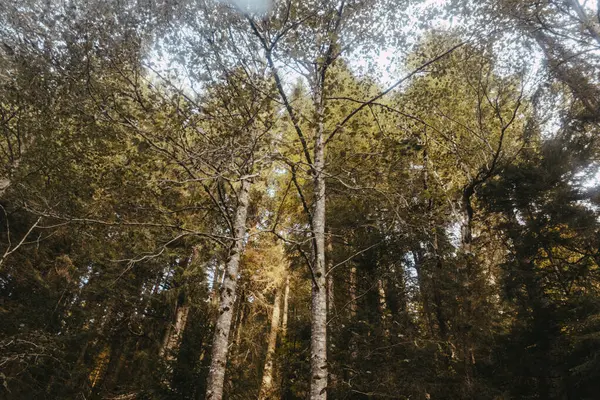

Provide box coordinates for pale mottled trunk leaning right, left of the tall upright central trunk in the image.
[206,179,251,400]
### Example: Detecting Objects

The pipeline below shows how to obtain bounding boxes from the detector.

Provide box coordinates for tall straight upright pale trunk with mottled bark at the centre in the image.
[310,97,327,400]
